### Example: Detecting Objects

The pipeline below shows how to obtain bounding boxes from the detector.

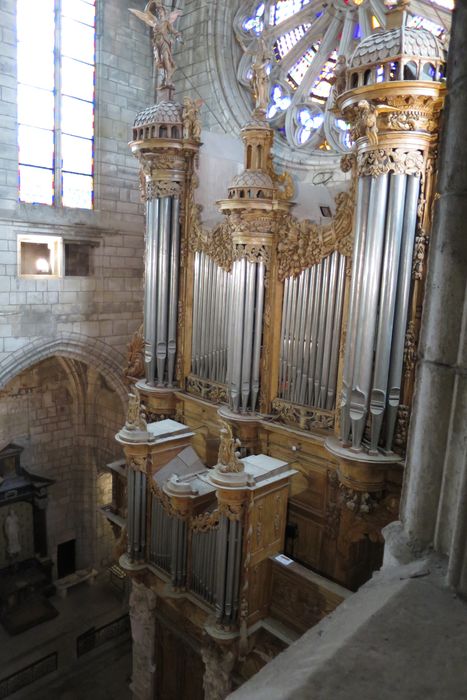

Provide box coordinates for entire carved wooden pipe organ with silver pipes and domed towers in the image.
[117,5,445,697]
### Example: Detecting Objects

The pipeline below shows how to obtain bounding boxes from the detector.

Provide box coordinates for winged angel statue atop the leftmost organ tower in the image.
[130,0,182,88]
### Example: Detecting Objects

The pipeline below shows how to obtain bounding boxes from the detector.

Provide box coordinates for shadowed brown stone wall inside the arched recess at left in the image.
[0,357,124,568]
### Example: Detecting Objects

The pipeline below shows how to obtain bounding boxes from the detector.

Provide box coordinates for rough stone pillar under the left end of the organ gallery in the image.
[130,579,157,700]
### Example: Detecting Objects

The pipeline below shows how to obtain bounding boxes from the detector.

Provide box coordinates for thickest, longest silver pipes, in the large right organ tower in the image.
[341,173,420,453]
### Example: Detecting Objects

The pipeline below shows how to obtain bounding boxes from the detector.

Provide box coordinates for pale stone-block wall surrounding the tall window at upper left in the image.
[0,0,153,366]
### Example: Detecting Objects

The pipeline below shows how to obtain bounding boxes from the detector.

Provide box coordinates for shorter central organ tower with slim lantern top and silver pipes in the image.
[219,117,293,414]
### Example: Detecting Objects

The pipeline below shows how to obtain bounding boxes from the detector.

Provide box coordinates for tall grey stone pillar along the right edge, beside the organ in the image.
[392,3,467,593]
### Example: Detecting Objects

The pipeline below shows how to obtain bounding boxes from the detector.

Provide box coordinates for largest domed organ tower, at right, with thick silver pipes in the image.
[326,7,445,491]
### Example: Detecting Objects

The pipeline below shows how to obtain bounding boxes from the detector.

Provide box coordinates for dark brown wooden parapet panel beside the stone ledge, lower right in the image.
[269,560,350,634]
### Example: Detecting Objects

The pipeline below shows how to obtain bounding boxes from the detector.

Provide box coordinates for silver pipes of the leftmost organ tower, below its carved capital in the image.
[144,197,180,386]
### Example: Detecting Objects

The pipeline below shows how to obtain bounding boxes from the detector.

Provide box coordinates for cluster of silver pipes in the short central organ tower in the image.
[226,258,265,412]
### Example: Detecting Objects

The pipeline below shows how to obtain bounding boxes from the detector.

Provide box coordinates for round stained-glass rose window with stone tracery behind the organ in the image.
[235,0,453,153]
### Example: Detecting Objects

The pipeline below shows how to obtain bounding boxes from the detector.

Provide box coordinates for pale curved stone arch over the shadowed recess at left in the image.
[0,333,128,406]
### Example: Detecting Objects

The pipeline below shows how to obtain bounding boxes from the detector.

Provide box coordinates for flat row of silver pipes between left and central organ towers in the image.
[191,252,231,384]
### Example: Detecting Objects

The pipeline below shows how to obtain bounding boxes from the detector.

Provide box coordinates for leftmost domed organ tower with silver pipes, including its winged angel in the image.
[127,3,201,418]
